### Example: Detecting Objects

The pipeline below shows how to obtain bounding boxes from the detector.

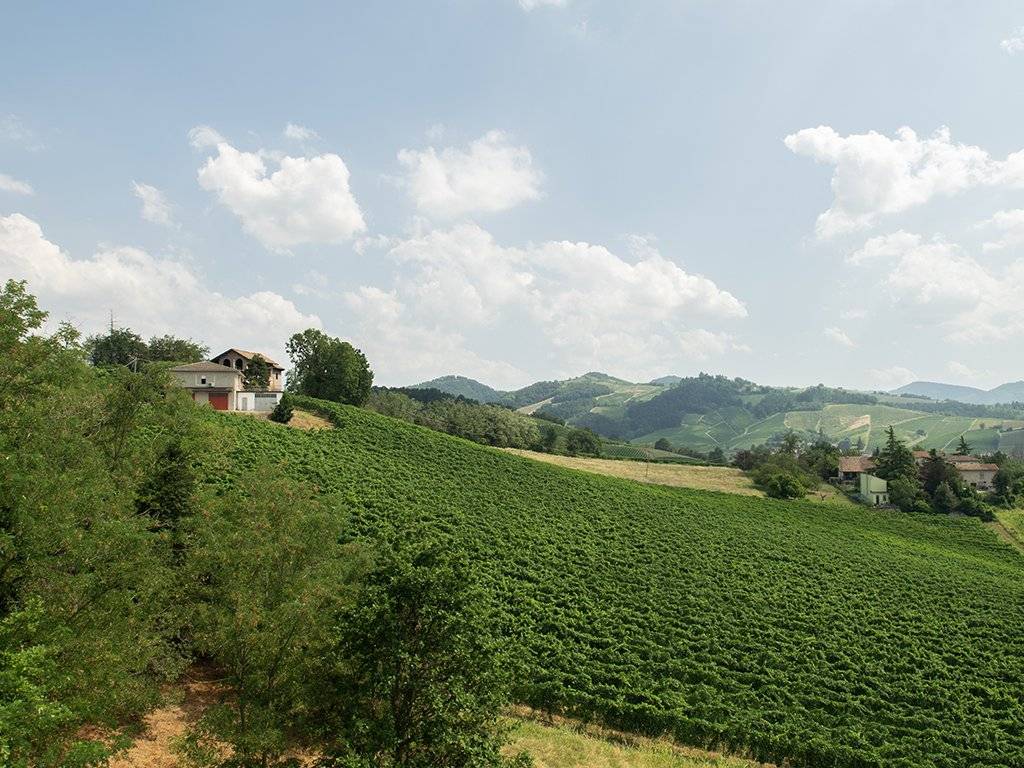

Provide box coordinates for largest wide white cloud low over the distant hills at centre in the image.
[351,223,746,378]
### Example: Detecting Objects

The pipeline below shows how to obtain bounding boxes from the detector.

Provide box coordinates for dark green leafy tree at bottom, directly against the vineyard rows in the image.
[323,542,528,768]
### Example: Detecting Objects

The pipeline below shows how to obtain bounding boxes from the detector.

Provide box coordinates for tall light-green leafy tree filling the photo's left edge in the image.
[0,282,187,768]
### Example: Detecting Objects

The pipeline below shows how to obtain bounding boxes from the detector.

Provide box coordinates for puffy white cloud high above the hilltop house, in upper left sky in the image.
[193,135,366,251]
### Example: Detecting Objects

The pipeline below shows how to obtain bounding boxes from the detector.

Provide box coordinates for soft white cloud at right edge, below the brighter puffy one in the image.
[849,231,1024,344]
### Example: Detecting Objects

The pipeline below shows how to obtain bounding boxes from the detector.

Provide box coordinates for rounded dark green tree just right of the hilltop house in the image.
[286,328,374,406]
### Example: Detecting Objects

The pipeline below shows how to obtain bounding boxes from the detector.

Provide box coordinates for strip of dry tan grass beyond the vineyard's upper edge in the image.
[508,449,764,496]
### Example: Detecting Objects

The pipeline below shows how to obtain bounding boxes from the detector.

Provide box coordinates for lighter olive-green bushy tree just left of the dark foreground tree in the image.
[183,469,365,768]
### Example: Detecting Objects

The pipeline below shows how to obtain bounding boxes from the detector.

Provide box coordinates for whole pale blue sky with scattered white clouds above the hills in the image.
[0,0,1024,389]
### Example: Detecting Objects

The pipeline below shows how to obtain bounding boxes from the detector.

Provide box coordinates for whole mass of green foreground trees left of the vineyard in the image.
[0,282,521,768]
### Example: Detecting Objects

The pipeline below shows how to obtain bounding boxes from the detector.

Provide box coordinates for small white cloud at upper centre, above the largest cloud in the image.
[398,131,543,218]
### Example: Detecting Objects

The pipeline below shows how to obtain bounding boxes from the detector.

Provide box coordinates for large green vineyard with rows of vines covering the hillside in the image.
[207,400,1024,768]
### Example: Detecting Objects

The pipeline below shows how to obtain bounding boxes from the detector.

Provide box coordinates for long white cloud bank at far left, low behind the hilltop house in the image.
[0,213,322,359]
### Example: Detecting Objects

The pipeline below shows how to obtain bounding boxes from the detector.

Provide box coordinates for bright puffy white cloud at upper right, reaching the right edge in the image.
[784,125,1024,238]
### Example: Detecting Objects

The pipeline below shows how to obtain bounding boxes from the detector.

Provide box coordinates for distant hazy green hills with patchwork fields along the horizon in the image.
[417,372,1024,455]
